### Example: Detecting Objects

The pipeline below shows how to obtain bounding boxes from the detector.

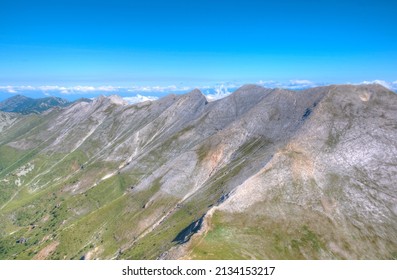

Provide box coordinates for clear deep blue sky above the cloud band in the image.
[0,0,397,99]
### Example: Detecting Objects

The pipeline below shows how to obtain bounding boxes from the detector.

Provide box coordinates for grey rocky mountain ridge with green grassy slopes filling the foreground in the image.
[0,85,397,259]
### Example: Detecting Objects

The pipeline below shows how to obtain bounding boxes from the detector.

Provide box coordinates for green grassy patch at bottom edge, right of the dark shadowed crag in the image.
[190,211,326,259]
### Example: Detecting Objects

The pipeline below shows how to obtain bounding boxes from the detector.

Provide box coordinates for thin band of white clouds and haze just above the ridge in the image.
[0,80,397,103]
